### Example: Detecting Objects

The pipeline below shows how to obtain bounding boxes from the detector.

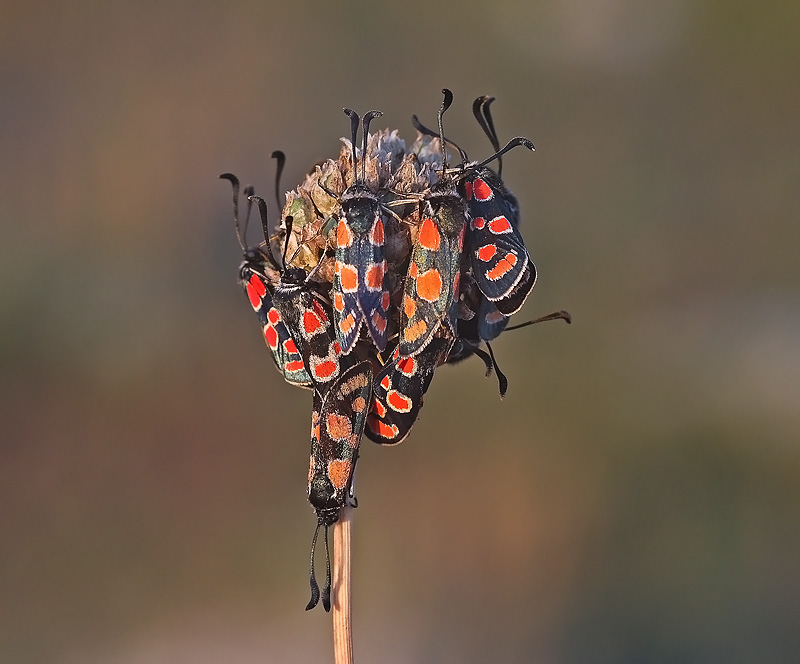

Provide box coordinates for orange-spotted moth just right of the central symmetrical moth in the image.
[398,89,468,357]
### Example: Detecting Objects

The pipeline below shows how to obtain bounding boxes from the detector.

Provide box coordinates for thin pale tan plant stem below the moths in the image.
[331,505,353,664]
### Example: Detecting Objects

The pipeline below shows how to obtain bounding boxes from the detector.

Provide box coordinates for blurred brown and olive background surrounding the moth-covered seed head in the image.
[0,0,800,664]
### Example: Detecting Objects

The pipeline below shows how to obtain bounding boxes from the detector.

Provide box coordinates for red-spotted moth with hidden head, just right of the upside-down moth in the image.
[364,337,453,445]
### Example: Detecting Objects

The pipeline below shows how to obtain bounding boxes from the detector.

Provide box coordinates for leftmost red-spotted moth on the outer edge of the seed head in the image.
[225,173,311,388]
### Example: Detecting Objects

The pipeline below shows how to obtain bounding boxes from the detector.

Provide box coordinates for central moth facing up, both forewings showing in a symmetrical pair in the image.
[332,108,389,353]
